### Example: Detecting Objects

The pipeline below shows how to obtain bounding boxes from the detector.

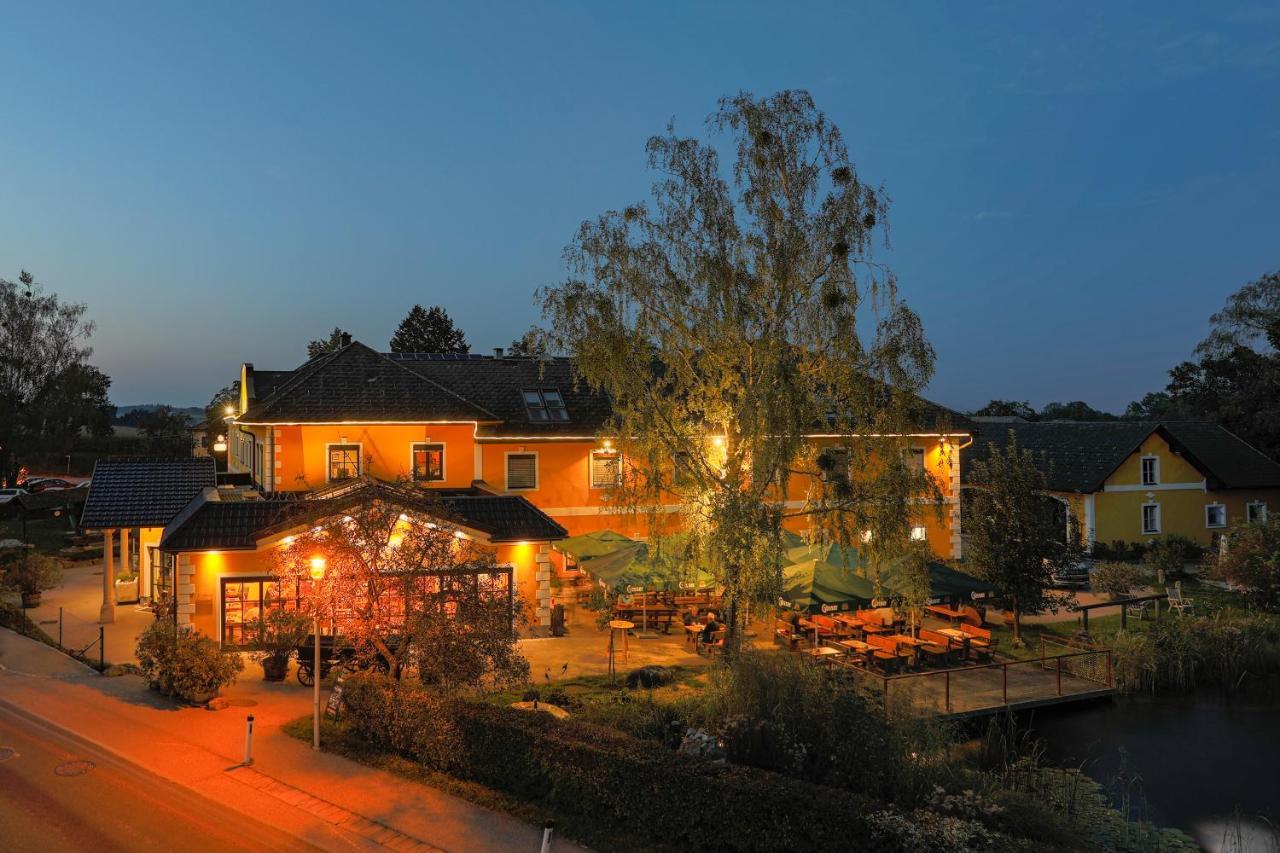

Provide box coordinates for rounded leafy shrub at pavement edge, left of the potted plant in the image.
[136,620,244,702]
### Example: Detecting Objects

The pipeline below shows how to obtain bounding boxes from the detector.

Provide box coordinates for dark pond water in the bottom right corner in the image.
[1030,683,1280,850]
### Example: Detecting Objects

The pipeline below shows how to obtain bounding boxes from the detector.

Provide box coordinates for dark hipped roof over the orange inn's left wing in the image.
[238,343,497,423]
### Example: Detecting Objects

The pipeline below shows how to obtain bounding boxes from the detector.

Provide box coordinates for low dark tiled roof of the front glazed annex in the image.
[160,480,566,551]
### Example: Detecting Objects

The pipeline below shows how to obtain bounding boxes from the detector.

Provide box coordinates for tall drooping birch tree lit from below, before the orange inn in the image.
[543,91,938,652]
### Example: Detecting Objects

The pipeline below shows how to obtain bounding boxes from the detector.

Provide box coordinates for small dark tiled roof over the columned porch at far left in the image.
[81,456,214,529]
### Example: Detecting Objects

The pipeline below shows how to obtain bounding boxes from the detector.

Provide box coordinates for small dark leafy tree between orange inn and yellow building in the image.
[964,434,1080,646]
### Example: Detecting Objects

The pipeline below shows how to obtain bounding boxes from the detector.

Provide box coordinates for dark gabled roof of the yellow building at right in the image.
[961,420,1280,493]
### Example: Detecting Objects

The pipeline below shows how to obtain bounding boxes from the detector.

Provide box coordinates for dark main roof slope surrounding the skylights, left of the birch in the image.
[385,352,611,437]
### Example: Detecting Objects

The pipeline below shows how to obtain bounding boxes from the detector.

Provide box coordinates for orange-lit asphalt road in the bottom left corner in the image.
[0,706,315,853]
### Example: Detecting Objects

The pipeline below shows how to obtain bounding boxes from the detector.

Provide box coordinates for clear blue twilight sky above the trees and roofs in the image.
[0,0,1280,410]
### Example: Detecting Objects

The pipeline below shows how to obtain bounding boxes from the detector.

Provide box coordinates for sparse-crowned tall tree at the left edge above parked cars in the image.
[0,270,110,483]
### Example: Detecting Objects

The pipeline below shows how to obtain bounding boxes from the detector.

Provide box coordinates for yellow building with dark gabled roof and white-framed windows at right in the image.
[966,420,1280,548]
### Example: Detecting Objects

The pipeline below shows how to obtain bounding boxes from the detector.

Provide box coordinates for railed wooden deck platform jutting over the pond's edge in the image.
[839,649,1115,719]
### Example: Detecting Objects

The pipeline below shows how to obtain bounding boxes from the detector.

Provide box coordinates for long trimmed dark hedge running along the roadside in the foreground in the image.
[343,675,884,850]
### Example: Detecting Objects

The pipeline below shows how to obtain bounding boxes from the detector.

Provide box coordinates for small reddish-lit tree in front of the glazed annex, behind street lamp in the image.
[274,485,529,690]
